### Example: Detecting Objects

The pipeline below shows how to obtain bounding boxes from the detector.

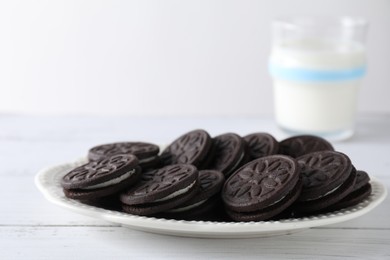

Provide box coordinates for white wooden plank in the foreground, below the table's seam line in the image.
[0,226,390,259]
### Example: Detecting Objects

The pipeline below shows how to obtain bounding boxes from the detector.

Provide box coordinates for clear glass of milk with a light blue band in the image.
[269,17,367,140]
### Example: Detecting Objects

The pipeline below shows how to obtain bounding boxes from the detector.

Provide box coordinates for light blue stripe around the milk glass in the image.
[269,63,366,81]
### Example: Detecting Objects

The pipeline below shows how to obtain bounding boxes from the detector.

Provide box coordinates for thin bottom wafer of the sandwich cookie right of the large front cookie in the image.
[295,169,356,214]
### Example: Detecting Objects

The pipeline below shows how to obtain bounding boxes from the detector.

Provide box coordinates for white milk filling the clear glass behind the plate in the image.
[269,38,366,139]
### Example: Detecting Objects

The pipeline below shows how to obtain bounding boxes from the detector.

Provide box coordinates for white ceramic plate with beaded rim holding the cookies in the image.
[35,159,387,238]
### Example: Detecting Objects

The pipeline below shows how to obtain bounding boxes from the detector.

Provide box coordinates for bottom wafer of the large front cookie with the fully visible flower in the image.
[226,180,302,222]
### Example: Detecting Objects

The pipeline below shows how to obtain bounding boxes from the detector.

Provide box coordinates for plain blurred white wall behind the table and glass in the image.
[0,0,390,116]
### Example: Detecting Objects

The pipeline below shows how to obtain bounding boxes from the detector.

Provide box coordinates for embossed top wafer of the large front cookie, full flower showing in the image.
[222,155,300,212]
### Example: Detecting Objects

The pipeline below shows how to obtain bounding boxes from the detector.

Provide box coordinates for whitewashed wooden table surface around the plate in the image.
[0,114,390,259]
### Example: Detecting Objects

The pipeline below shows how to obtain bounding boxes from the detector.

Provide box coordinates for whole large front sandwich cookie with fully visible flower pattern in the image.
[222,155,302,221]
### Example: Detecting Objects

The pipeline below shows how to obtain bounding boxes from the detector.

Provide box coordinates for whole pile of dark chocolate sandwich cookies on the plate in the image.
[61,129,371,222]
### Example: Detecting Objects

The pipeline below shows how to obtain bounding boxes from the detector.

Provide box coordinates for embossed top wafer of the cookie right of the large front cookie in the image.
[297,151,353,201]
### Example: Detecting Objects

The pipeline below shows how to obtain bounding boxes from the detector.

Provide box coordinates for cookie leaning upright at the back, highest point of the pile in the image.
[161,129,212,169]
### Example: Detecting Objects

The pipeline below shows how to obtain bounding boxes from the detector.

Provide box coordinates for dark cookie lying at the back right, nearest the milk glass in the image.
[279,135,334,158]
